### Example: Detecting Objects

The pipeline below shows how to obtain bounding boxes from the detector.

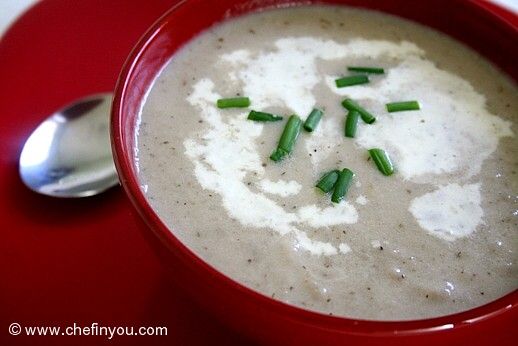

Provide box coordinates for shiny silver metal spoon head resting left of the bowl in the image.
[19,94,119,197]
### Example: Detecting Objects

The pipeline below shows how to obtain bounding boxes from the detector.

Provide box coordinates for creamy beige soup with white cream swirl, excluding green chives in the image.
[135,6,518,320]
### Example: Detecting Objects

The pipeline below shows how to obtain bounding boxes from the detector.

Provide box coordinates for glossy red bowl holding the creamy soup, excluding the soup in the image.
[112,0,518,345]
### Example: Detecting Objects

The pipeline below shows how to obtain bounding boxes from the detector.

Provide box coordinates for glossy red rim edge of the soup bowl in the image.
[110,0,518,337]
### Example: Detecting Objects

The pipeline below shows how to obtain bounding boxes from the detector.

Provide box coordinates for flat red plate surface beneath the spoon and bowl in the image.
[0,0,517,345]
